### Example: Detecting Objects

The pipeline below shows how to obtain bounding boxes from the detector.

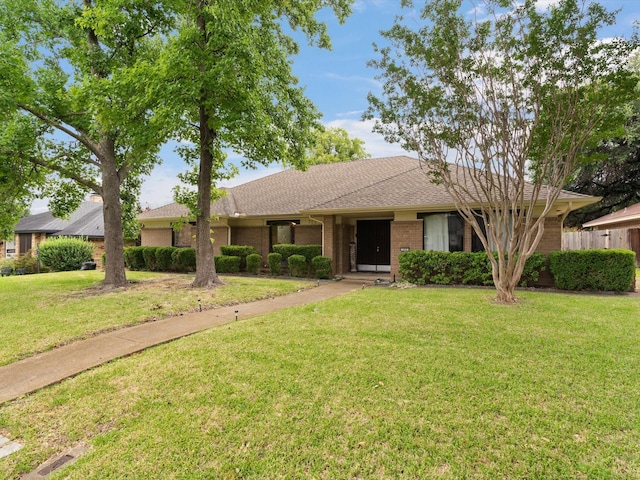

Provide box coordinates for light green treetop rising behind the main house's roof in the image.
[307,127,371,165]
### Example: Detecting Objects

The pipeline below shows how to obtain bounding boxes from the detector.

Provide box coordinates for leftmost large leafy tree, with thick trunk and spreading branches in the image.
[0,0,173,287]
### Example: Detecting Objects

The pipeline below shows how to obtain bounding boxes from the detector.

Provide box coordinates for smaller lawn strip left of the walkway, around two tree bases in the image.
[0,270,311,365]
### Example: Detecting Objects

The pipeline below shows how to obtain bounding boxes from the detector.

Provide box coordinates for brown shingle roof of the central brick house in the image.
[138,156,595,220]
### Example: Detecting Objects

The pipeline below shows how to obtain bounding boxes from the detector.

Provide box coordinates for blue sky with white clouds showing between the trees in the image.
[132,0,640,208]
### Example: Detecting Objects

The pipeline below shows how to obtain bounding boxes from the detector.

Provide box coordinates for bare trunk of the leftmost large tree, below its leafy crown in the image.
[100,139,127,288]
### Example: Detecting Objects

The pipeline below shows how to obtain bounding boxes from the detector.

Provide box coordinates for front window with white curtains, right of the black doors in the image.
[419,212,464,252]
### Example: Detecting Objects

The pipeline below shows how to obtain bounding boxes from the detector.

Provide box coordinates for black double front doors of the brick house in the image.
[356,220,391,272]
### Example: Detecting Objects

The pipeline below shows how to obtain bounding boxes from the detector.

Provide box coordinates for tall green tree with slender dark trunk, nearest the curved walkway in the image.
[163,0,351,287]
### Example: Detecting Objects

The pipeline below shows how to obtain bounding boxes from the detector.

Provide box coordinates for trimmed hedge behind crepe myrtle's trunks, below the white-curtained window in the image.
[398,250,546,287]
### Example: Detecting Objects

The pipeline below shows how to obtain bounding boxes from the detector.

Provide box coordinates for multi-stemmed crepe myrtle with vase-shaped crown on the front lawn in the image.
[365,0,635,303]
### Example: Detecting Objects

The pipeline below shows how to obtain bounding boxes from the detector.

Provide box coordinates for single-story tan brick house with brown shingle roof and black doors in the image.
[138,156,598,275]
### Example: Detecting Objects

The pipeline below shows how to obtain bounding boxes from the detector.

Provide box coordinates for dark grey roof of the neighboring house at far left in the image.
[15,202,104,238]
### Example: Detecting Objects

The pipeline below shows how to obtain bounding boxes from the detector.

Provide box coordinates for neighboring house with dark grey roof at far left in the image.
[1,196,104,263]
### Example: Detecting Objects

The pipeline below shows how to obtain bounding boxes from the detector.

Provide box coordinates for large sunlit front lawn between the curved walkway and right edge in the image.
[0,288,640,479]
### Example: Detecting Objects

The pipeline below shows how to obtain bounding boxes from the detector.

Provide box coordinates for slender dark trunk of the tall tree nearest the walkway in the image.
[191,99,222,288]
